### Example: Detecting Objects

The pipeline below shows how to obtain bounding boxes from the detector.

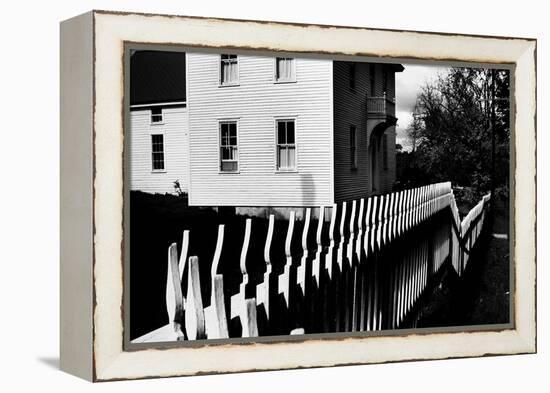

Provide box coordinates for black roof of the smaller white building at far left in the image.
[130,50,186,105]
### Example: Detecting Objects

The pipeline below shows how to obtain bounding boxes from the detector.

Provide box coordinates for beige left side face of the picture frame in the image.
[59,11,95,381]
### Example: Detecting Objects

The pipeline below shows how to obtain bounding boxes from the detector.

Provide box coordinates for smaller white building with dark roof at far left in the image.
[130,51,189,194]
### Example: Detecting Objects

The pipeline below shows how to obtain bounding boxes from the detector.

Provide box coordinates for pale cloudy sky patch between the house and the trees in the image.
[395,63,449,150]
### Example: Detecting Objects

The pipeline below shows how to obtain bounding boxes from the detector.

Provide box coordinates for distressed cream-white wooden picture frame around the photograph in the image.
[60,11,536,381]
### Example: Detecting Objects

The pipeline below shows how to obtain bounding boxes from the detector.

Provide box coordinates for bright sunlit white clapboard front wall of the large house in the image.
[187,53,333,206]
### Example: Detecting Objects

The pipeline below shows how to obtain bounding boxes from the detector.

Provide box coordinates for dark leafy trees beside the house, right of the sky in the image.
[398,68,510,192]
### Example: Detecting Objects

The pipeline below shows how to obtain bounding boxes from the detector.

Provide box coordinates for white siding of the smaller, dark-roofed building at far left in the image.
[128,107,189,194]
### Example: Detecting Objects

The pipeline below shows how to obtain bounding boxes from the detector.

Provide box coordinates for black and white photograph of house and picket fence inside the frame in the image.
[125,46,513,344]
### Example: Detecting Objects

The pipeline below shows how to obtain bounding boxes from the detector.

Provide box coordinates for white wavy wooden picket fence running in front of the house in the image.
[133,182,490,343]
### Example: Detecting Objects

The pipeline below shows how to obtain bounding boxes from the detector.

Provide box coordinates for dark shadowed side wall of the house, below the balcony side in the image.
[333,61,395,202]
